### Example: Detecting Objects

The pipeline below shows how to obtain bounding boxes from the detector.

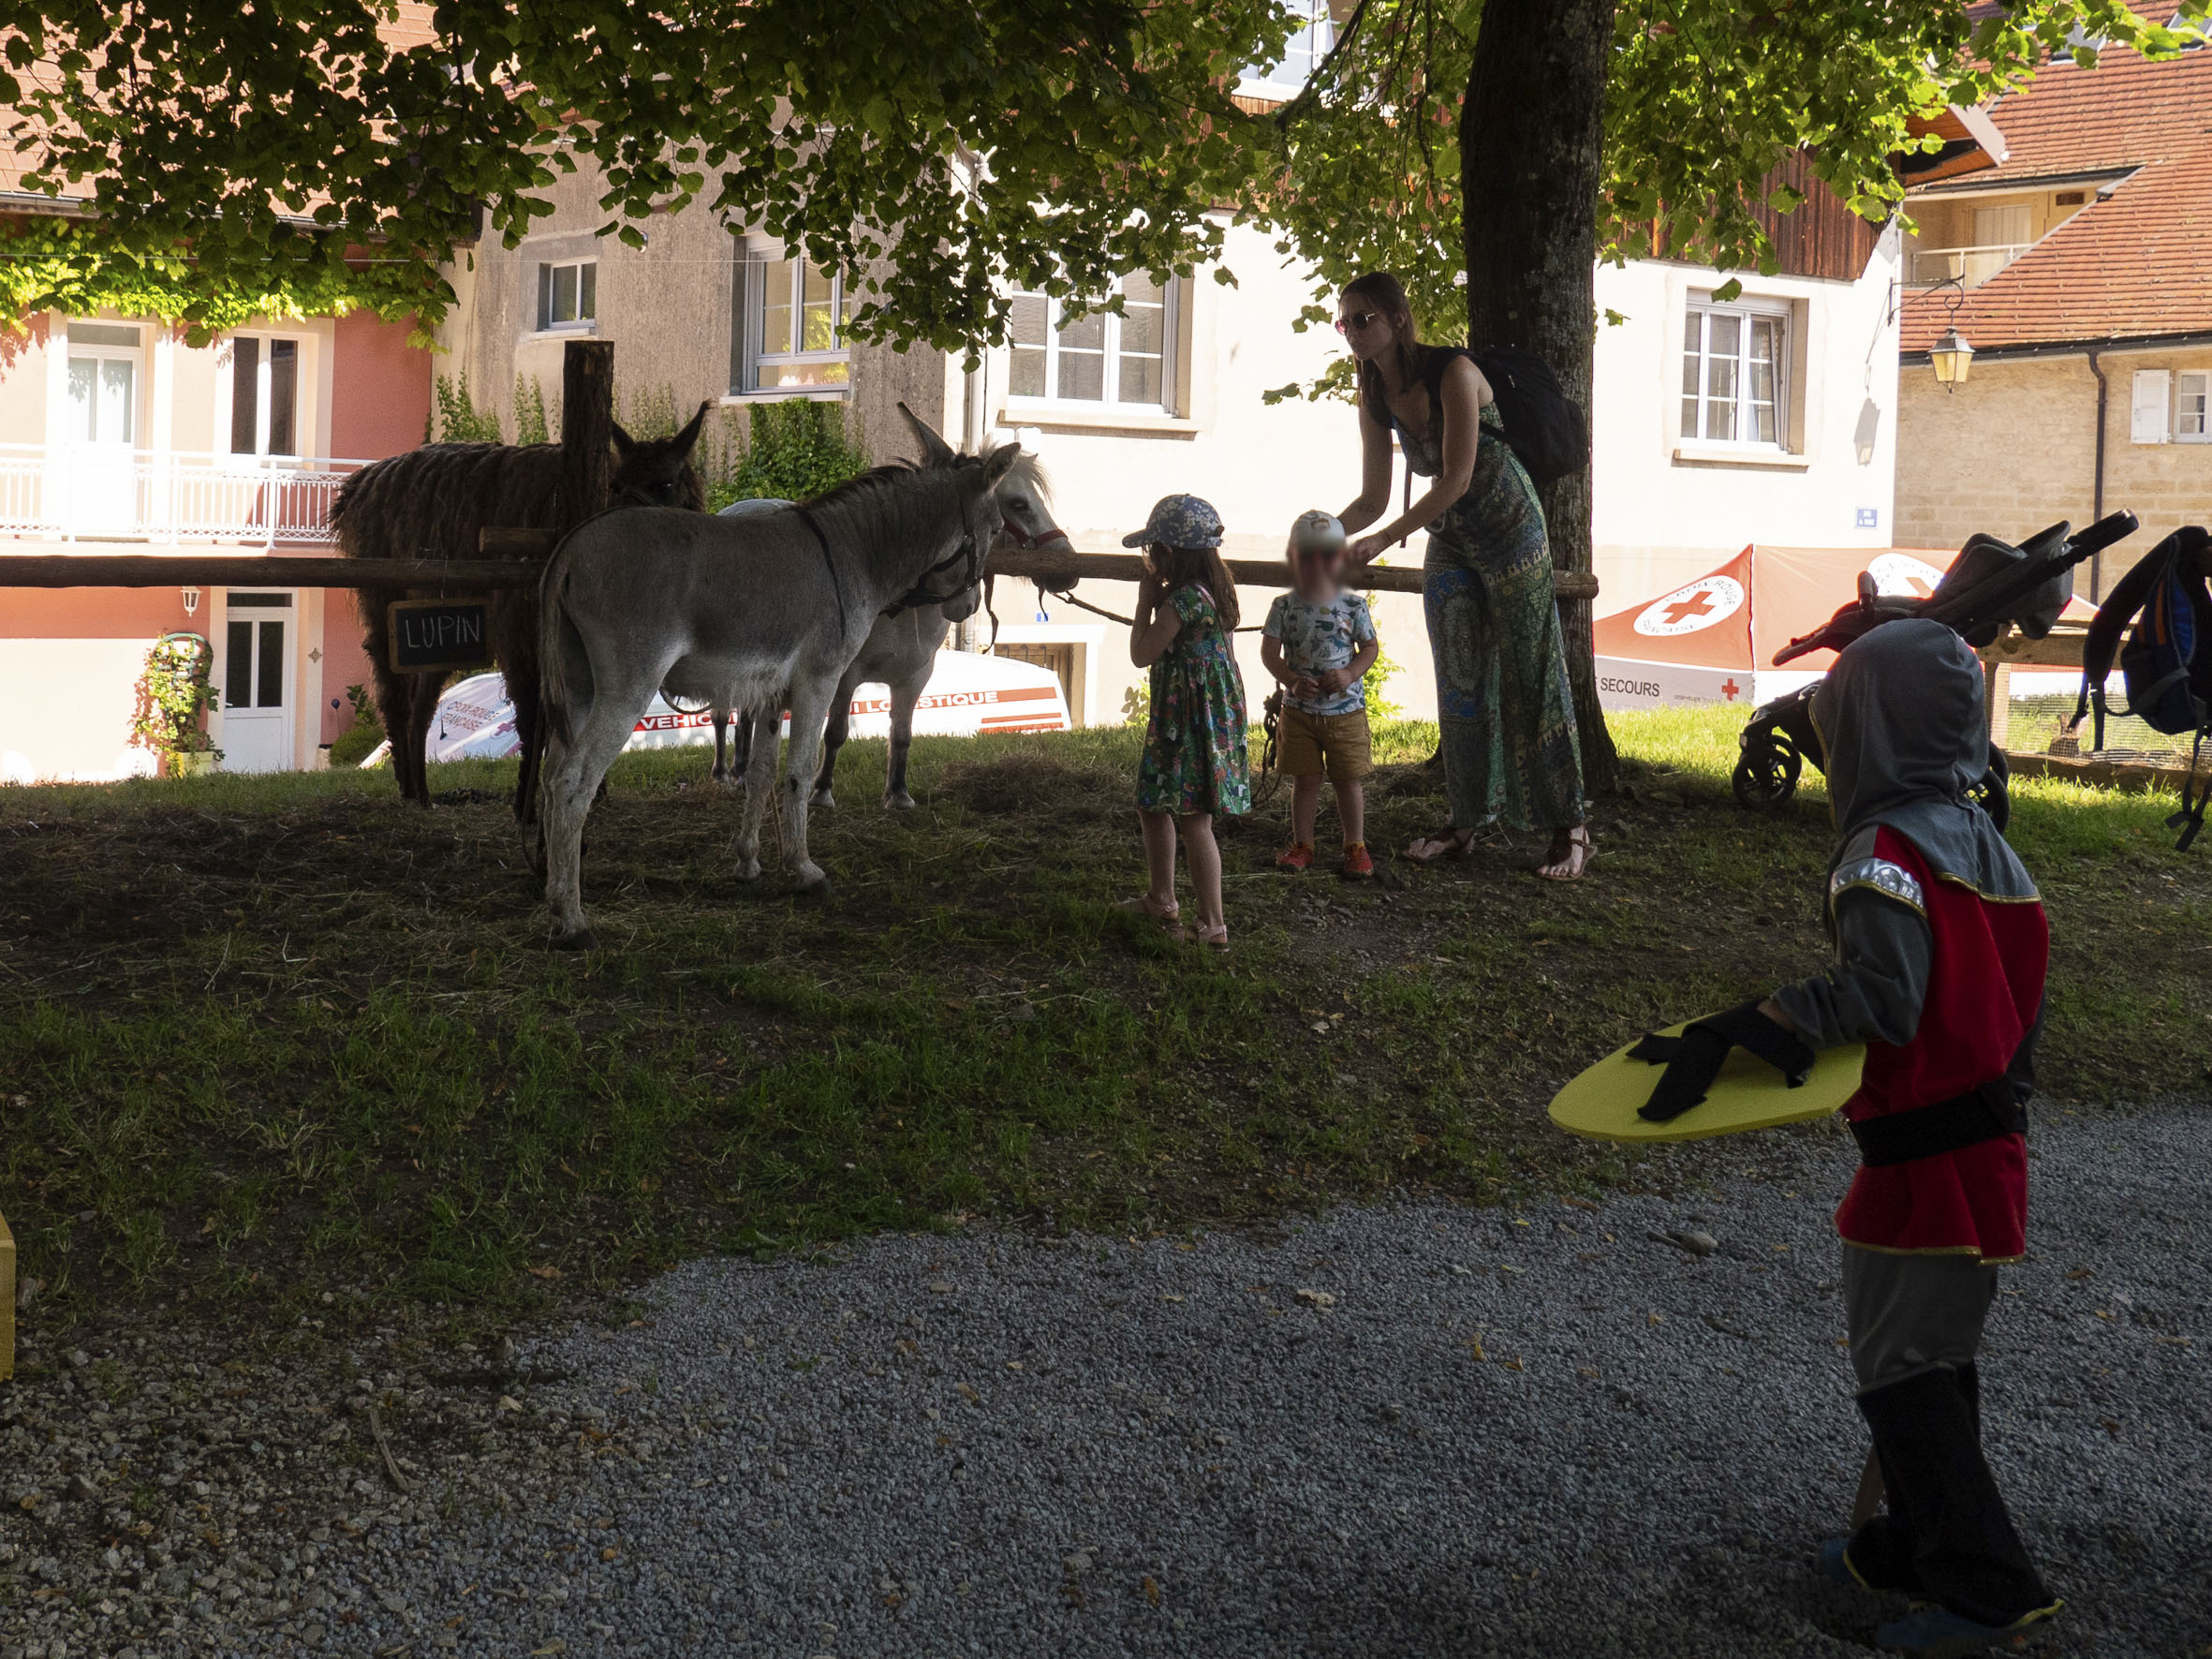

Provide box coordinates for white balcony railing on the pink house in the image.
[0,445,367,546]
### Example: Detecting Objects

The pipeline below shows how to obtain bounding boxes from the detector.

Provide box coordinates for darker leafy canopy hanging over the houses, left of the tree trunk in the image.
[0,0,1291,349]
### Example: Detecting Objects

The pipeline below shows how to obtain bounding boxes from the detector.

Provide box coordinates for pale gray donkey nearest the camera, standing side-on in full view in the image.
[538,431,1020,949]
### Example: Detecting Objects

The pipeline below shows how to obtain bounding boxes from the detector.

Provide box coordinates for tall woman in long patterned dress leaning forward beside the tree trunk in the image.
[1336,272,1590,881]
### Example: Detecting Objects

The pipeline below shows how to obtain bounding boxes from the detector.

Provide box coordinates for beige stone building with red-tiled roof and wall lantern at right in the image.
[1898,49,2212,600]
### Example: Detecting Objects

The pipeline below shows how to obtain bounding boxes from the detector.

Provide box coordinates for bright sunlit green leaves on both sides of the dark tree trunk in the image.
[1247,0,2207,396]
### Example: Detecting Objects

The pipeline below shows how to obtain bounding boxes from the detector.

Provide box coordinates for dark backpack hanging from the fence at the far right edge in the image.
[2072,525,2212,850]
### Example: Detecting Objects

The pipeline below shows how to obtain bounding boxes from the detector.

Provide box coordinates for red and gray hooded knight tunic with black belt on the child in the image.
[1774,622,2051,1263]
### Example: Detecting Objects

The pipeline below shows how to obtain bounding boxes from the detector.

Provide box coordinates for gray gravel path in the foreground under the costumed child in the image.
[0,1108,2212,1659]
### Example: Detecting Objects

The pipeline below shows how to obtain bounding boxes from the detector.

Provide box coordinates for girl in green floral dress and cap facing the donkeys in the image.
[1122,496,1252,951]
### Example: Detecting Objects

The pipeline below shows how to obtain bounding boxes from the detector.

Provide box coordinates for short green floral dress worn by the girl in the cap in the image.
[1137,582,1252,816]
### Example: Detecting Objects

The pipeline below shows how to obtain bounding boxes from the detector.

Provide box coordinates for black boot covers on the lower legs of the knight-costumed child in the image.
[1851,1367,2053,1626]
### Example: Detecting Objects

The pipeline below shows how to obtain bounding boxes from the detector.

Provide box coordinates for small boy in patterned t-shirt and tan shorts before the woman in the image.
[1259,511,1380,878]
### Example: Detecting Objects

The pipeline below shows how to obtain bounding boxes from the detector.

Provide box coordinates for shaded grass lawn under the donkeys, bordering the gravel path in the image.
[0,712,2212,1332]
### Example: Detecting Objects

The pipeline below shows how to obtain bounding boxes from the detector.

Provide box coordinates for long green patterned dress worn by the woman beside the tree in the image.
[1392,387,1584,830]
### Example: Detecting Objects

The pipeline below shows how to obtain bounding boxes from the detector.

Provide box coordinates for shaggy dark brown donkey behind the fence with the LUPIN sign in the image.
[330,403,708,822]
